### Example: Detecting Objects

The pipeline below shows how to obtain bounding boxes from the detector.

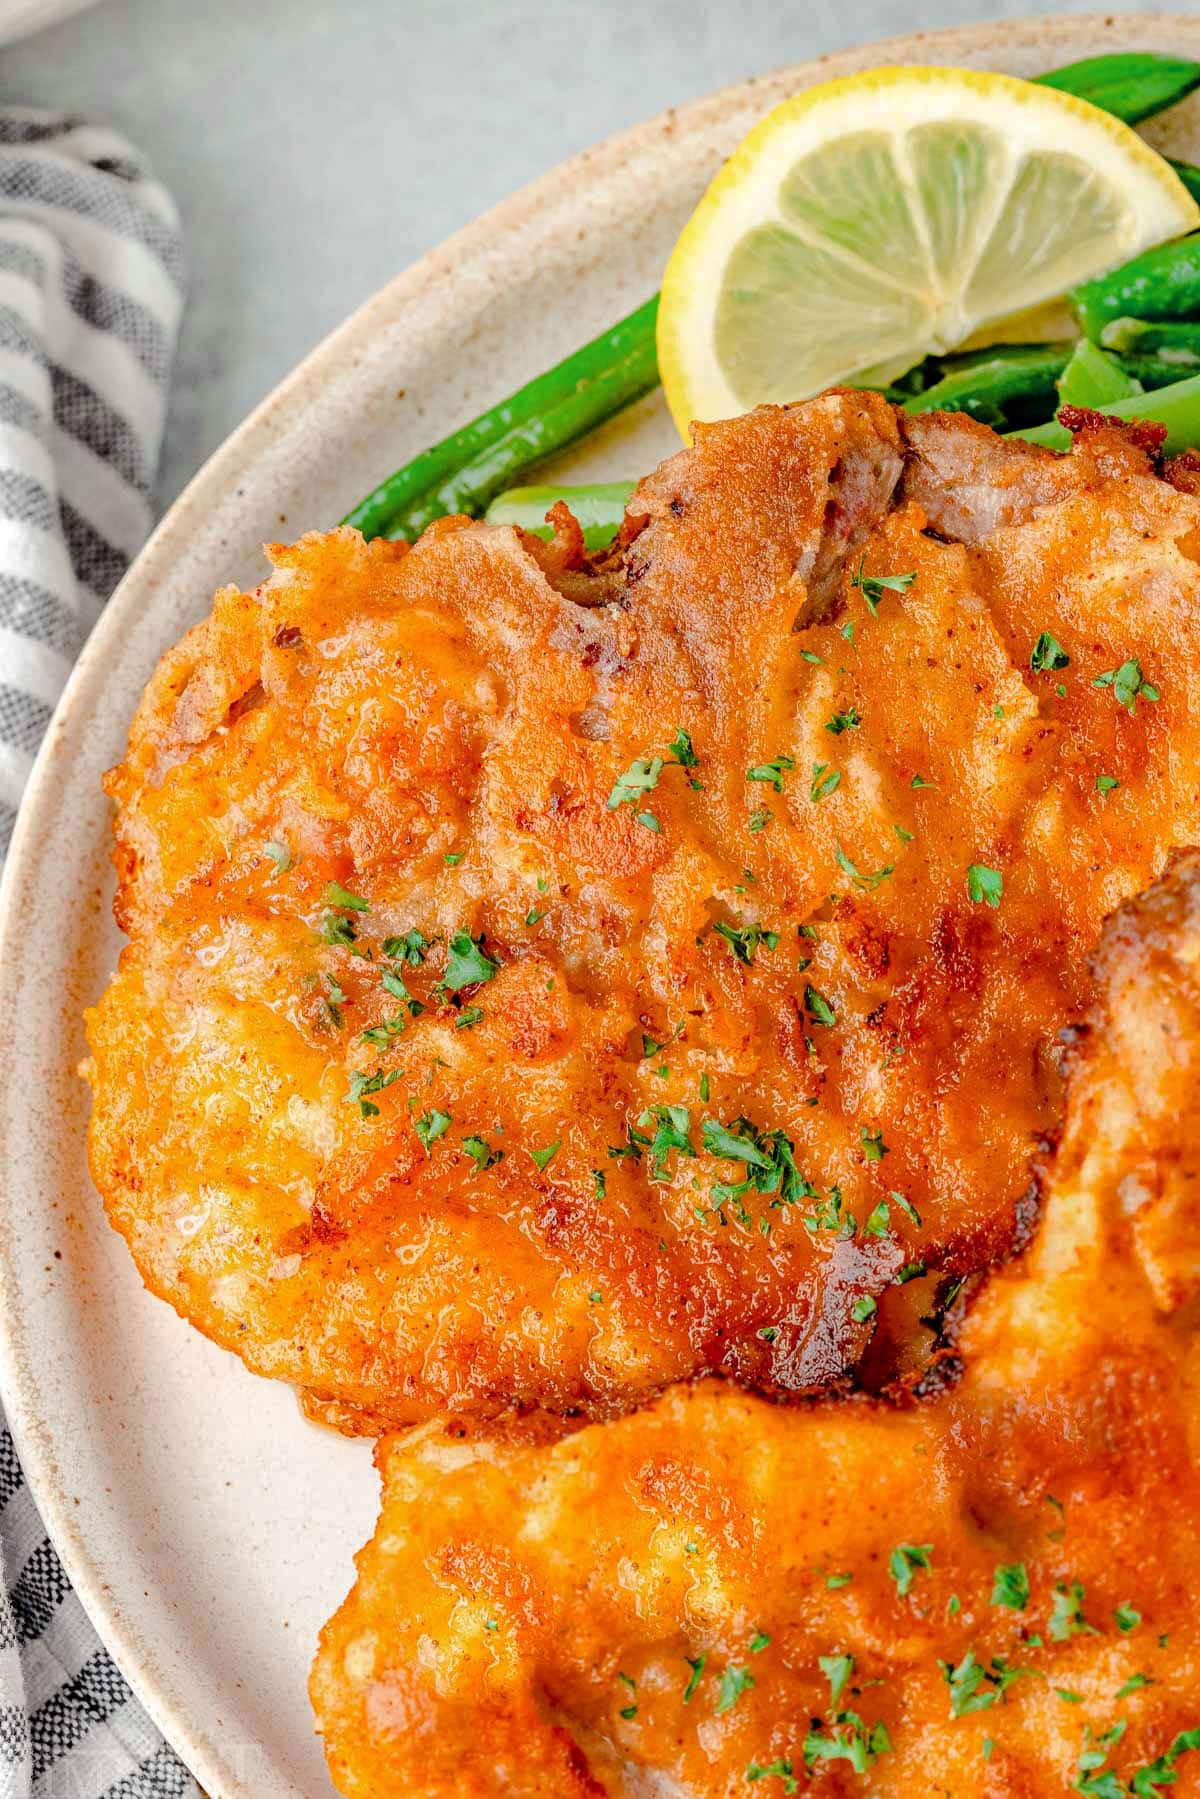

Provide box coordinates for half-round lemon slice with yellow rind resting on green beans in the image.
[658,68,1200,435]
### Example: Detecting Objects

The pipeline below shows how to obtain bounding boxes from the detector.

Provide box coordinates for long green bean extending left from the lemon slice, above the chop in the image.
[344,295,658,538]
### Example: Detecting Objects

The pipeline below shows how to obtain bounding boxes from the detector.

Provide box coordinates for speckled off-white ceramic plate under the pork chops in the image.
[0,14,1200,1799]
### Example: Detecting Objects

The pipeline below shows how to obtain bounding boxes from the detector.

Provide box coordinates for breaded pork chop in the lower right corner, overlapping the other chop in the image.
[311,853,1200,1799]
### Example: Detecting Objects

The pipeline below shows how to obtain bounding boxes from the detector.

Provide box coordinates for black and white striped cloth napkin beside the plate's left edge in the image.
[0,106,198,1799]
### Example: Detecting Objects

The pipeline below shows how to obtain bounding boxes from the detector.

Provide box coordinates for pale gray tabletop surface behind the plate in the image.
[0,0,1180,502]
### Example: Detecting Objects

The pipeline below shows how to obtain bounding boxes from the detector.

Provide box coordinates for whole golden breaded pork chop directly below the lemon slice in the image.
[88,392,1200,1428]
